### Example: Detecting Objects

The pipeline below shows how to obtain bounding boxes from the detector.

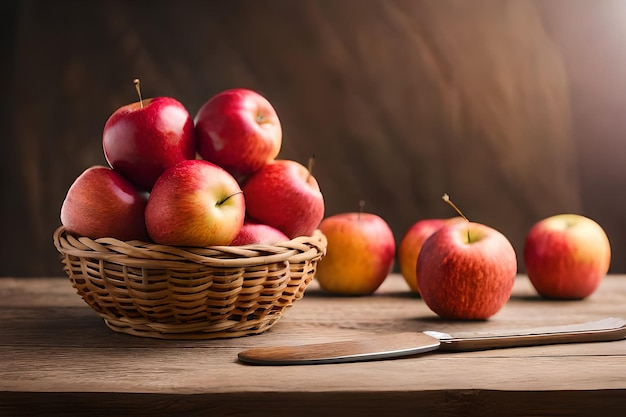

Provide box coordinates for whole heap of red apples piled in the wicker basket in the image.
[61,80,324,247]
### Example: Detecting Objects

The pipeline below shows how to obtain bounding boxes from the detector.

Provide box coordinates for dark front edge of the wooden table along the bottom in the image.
[0,390,624,417]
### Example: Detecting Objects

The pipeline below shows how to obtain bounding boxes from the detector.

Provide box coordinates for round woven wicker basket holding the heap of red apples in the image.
[54,227,327,339]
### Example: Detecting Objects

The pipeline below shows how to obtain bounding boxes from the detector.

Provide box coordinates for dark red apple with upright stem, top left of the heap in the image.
[102,81,196,191]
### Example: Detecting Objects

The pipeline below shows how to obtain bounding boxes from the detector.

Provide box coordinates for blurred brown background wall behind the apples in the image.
[0,0,626,276]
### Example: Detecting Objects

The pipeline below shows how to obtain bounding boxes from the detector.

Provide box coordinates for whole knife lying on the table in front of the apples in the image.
[238,318,626,365]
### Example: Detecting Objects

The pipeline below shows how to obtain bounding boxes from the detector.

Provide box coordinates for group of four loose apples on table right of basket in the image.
[316,194,611,320]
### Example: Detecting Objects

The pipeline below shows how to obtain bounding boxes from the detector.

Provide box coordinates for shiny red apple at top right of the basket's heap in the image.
[194,88,282,177]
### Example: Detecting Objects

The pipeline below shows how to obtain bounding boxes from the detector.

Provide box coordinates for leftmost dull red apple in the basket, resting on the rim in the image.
[61,165,148,241]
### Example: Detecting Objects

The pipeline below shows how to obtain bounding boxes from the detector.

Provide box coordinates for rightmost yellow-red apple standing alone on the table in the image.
[524,214,611,299]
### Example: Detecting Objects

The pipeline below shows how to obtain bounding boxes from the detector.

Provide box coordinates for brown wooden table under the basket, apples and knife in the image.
[0,275,626,417]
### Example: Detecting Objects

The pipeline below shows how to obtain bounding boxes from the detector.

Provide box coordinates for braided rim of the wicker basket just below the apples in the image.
[53,226,327,268]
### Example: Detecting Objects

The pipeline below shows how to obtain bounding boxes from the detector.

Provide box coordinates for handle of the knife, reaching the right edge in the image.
[432,318,626,351]
